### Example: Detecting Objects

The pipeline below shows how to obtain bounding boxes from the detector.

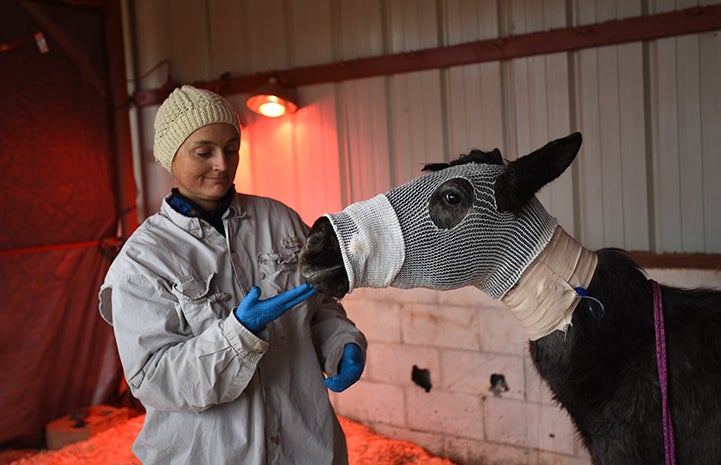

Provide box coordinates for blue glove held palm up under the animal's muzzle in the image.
[235,284,316,335]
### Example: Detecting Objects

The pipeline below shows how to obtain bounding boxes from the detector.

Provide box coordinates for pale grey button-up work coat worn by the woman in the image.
[100,194,367,465]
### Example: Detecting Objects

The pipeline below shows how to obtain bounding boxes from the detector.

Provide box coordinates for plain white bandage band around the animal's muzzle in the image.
[325,194,405,293]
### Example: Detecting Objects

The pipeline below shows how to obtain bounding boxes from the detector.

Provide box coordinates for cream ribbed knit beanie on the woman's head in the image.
[153,85,240,171]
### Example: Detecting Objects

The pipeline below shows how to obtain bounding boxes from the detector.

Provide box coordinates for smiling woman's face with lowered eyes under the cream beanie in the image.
[171,123,240,210]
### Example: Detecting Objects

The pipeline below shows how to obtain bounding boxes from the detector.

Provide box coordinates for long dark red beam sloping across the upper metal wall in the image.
[133,5,721,106]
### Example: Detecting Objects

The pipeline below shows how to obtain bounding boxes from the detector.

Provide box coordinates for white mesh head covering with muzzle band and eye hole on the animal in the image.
[325,163,558,299]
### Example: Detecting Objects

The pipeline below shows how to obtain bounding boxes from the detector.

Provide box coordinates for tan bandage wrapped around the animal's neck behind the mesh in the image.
[501,226,598,341]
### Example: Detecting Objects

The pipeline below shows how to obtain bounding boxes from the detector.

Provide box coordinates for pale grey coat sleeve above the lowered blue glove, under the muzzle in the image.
[311,294,368,377]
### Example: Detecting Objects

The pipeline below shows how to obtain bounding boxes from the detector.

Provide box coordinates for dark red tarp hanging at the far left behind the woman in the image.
[0,1,126,448]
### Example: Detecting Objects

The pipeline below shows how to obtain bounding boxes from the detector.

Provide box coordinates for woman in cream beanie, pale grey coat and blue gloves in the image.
[100,85,366,465]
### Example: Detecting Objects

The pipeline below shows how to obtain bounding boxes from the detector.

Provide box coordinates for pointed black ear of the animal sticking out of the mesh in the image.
[495,132,581,213]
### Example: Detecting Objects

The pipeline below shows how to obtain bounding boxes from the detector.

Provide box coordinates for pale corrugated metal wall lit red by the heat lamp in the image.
[129,0,721,253]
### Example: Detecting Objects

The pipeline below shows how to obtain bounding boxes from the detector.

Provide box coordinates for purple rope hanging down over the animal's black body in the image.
[649,279,676,465]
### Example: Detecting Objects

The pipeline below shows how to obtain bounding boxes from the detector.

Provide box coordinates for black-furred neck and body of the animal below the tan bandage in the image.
[530,249,721,465]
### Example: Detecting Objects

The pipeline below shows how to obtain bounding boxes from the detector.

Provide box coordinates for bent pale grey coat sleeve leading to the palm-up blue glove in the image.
[100,275,268,412]
